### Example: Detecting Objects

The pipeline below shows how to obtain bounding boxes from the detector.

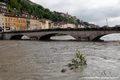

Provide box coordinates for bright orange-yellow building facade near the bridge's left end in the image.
[4,15,27,31]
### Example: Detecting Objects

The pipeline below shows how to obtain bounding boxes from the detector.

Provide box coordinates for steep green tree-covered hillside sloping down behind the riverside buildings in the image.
[4,0,80,24]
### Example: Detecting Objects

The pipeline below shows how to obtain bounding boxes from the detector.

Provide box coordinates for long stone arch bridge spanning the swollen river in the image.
[0,27,120,41]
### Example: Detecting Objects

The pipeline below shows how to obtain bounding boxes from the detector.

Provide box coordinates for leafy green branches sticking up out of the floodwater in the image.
[68,50,87,69]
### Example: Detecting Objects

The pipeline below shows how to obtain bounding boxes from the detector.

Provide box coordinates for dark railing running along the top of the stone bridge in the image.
[4,27,120,33]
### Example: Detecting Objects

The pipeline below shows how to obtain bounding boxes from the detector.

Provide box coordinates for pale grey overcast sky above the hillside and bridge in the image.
[31,0,120,26]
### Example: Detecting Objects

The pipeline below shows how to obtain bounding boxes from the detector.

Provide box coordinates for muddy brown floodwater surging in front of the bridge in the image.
[0,41,120,80]
